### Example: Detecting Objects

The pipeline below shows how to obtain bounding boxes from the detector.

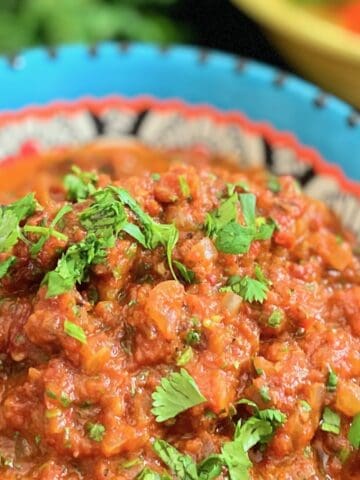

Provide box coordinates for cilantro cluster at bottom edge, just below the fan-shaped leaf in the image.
[153,400,286,480]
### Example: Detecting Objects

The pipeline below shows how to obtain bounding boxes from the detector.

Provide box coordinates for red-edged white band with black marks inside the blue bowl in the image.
[0,97,360,242]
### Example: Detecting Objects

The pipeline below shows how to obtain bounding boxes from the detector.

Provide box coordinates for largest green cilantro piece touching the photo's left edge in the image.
[0,193,37,253]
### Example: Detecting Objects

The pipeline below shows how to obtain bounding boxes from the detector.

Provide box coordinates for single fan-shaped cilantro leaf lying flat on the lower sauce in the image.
[151,368,206,422]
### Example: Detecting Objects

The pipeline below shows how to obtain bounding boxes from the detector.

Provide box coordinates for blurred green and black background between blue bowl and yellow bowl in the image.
[0,0,289,69]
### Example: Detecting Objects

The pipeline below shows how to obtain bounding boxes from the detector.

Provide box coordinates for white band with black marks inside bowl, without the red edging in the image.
[0,105,360,244]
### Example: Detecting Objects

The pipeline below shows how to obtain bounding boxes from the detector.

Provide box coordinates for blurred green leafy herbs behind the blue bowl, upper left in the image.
[0,0,188,52]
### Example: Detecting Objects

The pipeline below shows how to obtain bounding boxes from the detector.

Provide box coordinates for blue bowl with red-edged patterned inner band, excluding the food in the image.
[0,43,360,236]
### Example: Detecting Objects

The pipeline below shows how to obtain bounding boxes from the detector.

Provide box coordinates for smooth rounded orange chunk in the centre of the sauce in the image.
[146,280,185,340]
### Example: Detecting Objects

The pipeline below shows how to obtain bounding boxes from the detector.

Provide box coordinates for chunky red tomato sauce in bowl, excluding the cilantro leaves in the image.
[0,145,360,480]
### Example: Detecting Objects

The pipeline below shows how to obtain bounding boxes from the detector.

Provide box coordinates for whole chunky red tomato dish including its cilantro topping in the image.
[0,144,360,480]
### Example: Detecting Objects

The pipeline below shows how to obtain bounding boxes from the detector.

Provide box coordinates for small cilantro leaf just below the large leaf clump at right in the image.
[220,266,268,303]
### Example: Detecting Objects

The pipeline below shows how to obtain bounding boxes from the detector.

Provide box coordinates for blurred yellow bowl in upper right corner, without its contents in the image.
[232,0,360,108]
